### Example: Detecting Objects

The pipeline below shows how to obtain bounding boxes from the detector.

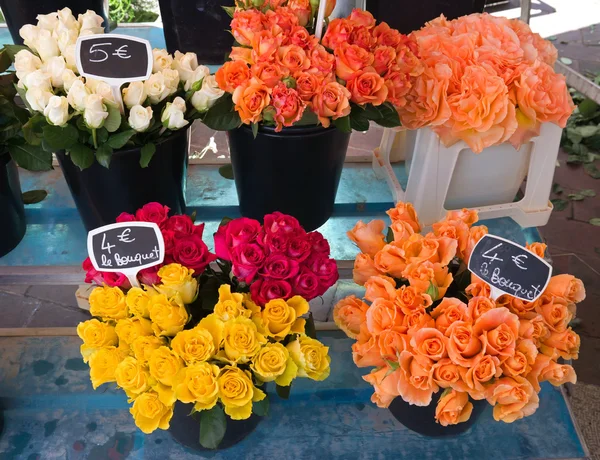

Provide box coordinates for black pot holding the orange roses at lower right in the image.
[389,390,488,438]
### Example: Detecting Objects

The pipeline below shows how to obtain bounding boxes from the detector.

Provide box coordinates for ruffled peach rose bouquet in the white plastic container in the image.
[398,13,574,153]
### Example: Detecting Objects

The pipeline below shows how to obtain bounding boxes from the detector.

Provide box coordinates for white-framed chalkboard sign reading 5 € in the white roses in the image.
[75,34,153,86]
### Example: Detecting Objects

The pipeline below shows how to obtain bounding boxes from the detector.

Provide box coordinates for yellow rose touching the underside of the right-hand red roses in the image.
[261,296,309,340]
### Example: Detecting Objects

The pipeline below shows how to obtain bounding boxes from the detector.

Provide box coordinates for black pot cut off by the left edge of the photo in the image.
[0,154,26,257]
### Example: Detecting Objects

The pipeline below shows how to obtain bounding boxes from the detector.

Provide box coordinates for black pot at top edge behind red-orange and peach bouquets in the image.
[367,0,485,34]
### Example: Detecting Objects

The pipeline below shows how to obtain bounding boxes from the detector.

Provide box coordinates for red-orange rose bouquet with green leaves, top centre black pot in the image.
[203,4,406,133]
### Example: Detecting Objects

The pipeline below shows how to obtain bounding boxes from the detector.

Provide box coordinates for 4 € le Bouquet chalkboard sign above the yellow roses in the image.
[87,222,165,286]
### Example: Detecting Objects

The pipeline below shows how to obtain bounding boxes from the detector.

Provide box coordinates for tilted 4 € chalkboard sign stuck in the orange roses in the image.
[469,235,552,302]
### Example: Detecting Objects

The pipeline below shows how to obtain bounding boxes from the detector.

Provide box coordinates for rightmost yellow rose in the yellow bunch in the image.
[287,336,331,380]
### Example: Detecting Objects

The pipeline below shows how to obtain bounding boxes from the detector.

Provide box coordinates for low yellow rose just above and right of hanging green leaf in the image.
[218,366,266,420]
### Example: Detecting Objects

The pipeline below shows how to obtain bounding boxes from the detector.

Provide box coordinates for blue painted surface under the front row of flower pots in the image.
[0,332,585,460]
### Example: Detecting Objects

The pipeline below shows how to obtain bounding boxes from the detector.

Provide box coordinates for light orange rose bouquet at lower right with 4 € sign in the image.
[334,202,585,426]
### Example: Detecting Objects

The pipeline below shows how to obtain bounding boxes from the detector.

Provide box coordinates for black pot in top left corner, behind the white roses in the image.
[0,0,108,45]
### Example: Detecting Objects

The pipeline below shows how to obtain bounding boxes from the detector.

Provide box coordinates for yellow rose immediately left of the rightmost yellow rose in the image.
[250,343,298,387]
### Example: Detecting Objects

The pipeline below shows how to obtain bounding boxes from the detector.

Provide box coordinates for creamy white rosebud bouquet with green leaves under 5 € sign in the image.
[5,8,223,169]
